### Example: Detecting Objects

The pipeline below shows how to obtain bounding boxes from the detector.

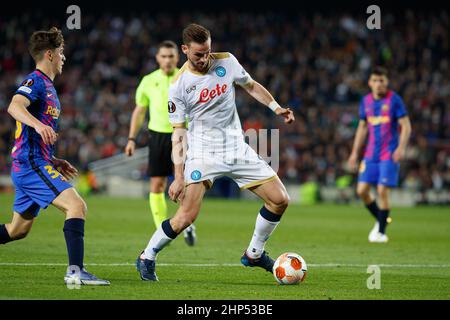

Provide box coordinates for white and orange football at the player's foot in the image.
[273,252,308,284]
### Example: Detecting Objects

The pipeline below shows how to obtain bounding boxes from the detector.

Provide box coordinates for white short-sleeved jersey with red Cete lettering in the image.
[168,52,252,158]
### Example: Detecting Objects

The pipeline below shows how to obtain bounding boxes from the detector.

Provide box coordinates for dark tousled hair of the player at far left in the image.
[28,27,64,62]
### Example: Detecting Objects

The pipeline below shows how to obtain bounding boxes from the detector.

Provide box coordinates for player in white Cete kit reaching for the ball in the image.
[136,24,295,281]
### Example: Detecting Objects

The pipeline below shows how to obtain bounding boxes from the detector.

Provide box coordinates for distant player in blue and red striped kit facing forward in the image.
[349,67,411,243]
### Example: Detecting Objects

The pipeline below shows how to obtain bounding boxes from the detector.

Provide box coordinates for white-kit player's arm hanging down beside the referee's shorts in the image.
[169,124,187,202]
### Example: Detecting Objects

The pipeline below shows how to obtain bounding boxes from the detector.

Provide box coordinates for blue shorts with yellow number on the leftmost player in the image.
[11,161,72,217]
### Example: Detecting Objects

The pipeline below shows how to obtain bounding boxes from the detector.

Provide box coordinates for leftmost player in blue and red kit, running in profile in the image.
[0,27,109,285]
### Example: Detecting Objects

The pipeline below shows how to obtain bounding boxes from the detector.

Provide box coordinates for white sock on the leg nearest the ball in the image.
[246,213,280,259]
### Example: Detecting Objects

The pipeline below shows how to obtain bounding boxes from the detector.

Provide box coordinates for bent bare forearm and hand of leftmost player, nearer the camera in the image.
[8,94,57,144]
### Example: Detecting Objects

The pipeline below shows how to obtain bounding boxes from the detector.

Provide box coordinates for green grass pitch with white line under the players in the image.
[0,195,450,300]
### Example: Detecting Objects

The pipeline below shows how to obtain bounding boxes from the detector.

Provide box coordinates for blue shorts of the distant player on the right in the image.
[358,159,400,188]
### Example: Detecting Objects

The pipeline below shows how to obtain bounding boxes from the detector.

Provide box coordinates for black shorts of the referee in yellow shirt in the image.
[148,130,173,177]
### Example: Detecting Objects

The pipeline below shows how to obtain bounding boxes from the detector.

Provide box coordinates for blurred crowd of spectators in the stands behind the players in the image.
[0,11,450,191]
